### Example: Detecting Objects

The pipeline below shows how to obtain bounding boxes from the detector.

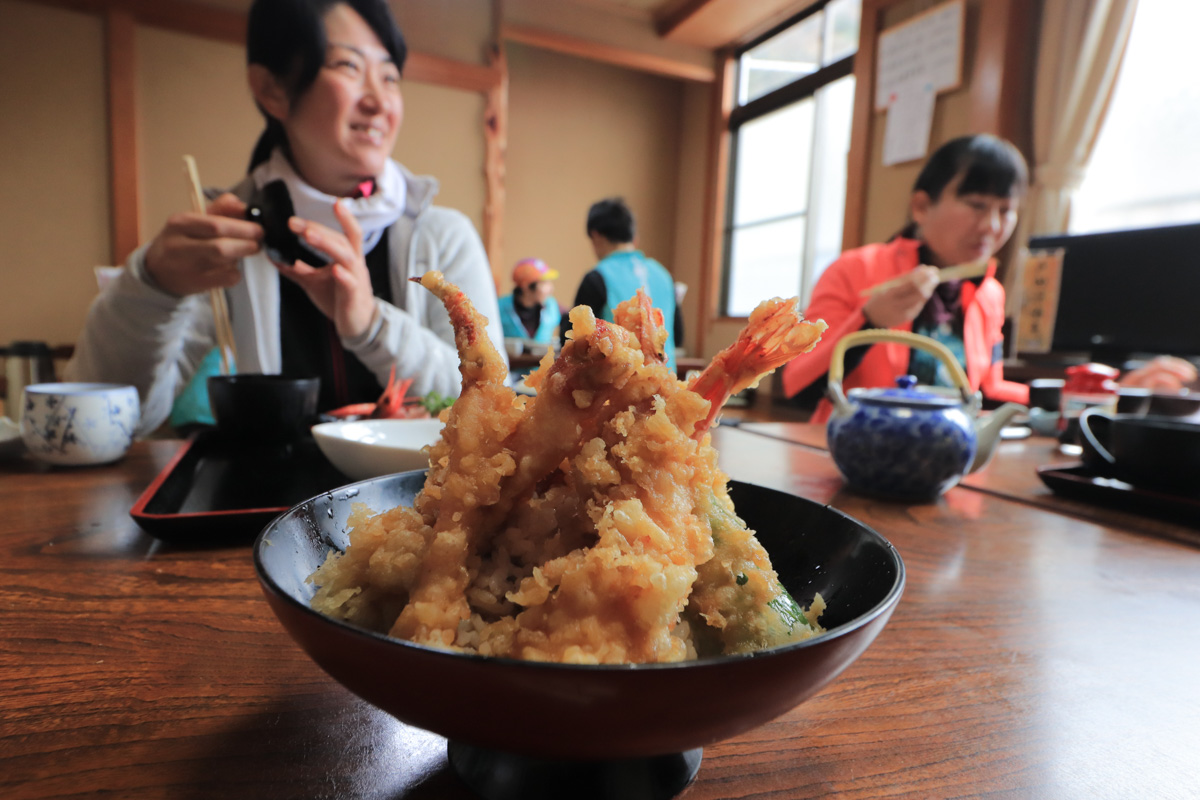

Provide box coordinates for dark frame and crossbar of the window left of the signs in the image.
[716,0,865,319]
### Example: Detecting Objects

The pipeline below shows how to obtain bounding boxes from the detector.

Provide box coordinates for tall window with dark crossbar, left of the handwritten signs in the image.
[721,0,860,317]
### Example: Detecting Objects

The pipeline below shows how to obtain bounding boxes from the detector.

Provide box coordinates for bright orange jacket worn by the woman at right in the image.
[784,239,1030,422]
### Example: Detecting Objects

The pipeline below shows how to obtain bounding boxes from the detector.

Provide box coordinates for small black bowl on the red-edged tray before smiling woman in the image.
[208,373,320,446]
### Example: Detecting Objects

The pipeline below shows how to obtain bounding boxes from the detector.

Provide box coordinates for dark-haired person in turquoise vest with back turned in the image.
[562,198,683,369]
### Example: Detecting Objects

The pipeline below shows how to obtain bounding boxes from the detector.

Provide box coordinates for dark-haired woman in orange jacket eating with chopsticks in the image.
[782,134,1028,422]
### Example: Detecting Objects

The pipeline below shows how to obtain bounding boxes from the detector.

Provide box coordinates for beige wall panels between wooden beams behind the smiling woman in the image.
[0,0,491,357]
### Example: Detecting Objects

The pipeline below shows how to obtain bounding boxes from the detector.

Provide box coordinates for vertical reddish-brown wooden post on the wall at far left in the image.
[104,8,142,264]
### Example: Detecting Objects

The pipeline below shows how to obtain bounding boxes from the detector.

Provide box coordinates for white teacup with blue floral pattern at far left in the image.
[20,384,140,467]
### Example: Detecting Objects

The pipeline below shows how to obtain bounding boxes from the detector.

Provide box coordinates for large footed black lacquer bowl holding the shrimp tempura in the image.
[254,471,905,800]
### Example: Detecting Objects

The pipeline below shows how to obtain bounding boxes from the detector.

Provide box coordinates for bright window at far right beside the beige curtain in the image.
[1070,0,1200,233]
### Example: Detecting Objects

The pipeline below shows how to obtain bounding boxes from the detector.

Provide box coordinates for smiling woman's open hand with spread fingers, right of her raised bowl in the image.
[276,201,377,338]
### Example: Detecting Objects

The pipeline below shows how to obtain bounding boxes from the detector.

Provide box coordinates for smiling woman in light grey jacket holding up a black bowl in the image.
[67,0,504,433]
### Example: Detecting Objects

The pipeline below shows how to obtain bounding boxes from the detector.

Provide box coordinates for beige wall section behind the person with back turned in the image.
[504,44,703,340]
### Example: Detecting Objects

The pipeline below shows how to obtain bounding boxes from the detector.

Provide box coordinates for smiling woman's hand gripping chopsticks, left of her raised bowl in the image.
[145,193,263,297]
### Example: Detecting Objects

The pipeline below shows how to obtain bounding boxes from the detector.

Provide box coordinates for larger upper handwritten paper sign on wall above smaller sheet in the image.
[875,0,966,112]
